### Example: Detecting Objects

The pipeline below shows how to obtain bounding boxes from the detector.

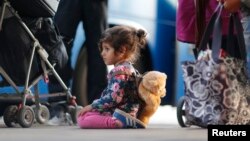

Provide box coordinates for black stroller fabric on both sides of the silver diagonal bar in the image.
[0,6,68,86]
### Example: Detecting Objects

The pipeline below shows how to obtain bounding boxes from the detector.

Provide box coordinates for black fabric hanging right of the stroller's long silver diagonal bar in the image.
[23,18,68,70]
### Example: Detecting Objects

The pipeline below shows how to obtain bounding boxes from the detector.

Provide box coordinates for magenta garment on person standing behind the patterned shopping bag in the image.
[176,0,229,43]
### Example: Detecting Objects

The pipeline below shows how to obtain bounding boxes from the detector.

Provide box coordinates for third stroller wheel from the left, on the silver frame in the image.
[32,105,50,124]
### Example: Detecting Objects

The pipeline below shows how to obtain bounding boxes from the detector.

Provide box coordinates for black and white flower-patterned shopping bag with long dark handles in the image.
[182,4,250,127]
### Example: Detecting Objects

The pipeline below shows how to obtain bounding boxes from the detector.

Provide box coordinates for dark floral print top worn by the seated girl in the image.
[91,62,139,117]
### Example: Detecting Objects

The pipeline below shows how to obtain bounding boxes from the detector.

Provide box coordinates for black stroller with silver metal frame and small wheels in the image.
[0,0,81,128]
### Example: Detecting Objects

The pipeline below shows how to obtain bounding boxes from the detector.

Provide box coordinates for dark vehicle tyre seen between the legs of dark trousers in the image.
[72,47,88,106]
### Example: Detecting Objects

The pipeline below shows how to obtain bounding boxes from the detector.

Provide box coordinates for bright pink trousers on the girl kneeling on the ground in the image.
[77,112,119,129]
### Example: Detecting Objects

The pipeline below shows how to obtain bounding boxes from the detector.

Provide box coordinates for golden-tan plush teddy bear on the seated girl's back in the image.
[138,71,167,126]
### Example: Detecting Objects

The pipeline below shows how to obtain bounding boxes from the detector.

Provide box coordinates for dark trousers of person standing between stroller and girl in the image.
[50,0,107,102]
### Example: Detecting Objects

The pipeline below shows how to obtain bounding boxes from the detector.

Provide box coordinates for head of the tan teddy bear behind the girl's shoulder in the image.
[138,71,167,101]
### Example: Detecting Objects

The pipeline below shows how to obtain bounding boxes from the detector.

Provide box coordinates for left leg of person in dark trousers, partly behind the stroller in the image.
[49,0,82,97]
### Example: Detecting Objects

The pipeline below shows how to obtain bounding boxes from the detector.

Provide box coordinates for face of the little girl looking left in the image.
[101,42,122,65]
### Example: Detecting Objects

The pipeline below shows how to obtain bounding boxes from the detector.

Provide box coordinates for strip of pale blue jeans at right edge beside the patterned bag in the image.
[241,16,250,76]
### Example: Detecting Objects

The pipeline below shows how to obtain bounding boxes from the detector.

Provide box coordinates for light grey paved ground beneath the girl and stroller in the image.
[0,106,207,141]
